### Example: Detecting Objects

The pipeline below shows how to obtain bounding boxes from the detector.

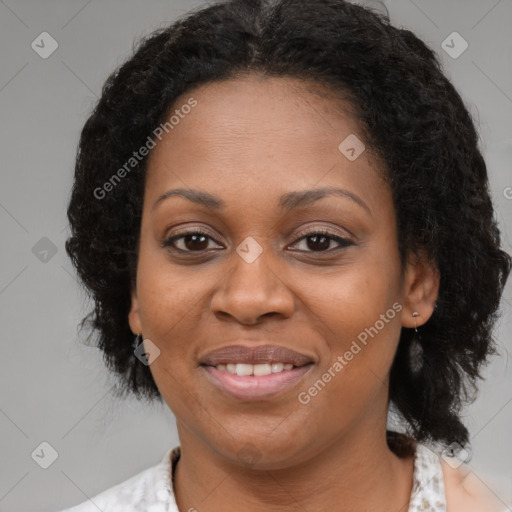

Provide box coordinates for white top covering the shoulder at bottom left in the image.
[55,449,176,512]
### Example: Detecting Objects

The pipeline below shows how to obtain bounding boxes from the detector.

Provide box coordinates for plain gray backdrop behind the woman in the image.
[0,0,512,512]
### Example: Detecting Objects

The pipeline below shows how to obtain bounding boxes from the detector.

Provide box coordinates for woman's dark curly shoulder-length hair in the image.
[66,0,511,454]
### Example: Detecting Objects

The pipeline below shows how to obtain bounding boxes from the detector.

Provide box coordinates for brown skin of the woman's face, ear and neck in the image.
[129,76,439,512]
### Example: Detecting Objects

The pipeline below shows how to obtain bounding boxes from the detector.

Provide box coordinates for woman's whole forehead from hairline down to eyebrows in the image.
[142,75,382,212]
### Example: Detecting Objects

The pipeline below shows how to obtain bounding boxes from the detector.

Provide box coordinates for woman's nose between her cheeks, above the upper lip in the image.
[210,251,295,325]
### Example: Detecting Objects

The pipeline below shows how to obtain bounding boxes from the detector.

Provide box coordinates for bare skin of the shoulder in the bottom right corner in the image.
[440,457,509,512]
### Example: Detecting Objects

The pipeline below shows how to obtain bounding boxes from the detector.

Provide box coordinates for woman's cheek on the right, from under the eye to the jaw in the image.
[296,247,402,396]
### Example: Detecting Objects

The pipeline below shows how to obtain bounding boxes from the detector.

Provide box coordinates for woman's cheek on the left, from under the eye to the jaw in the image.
[133,248,221,402]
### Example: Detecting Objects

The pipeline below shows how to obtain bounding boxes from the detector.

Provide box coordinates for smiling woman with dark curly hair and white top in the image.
[59,0,511,512]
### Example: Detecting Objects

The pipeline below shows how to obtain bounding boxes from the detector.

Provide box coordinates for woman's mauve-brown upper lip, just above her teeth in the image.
[200,345,313,366]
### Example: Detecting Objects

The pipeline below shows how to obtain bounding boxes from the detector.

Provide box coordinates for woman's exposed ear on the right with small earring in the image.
[402,252,440,328]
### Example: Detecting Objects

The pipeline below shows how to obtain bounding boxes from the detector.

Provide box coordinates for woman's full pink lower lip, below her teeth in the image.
[201,364,313,401]
